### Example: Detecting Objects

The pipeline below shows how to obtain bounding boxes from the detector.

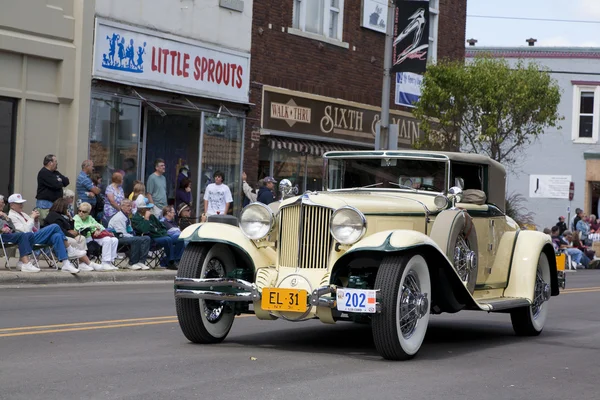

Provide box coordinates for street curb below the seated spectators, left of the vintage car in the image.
[0,270,177,286]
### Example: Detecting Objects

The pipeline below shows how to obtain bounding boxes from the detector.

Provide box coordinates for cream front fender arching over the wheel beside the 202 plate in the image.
[331,229,479,312]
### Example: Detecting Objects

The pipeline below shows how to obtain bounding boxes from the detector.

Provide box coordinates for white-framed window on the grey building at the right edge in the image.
[571,86,600,143]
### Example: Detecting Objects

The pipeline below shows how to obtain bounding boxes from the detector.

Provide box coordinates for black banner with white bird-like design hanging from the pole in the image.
[391,0,429,73]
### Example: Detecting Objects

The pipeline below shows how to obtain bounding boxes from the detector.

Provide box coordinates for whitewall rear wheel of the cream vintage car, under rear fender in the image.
[510,253,551,336]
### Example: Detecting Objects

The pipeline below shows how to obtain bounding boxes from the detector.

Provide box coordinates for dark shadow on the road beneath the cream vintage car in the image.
[223,316,568,360]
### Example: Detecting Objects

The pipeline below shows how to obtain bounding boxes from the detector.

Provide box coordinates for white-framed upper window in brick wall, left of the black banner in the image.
[293,0,344,41]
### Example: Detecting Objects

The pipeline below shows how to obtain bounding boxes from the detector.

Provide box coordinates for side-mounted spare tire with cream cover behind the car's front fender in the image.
[430,210,479,294]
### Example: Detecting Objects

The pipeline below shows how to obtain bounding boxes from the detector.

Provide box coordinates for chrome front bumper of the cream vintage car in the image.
[175,277,336,308]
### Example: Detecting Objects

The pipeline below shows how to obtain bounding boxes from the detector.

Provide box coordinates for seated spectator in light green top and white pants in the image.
[73,203,119,271]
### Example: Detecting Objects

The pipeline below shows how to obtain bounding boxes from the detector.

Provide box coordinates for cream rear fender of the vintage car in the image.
[504,230,559,301]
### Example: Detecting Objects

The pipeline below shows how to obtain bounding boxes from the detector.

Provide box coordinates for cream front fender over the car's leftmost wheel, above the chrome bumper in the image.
[179,222,277,271]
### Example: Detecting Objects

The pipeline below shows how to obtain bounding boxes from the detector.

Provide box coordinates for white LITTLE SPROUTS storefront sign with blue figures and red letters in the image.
[93,19,250,103]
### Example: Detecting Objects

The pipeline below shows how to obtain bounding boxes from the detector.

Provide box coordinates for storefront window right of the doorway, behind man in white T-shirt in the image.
[200,113,244,215]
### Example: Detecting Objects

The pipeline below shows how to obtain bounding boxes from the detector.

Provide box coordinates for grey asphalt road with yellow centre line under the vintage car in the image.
[0,271,600,400]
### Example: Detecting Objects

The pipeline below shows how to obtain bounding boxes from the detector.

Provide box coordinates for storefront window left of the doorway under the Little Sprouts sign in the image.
[90,94,141,195]
